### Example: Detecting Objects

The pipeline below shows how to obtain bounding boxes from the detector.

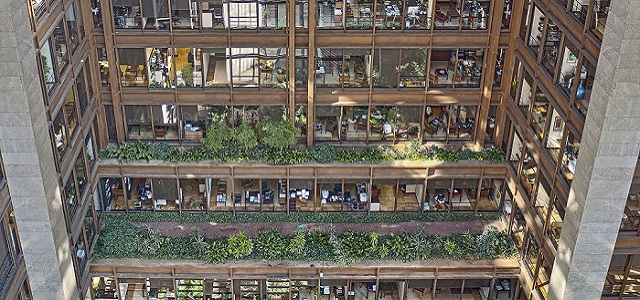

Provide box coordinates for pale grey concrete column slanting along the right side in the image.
[548,0,640,300]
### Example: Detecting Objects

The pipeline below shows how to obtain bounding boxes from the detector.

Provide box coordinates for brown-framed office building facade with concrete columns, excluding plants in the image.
[0,0,640,299]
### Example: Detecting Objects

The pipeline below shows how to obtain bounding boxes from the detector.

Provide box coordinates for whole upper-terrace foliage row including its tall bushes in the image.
[99,136,505,165]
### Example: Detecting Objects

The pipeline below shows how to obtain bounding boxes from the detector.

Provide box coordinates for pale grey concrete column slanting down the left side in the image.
[0,0,79,300]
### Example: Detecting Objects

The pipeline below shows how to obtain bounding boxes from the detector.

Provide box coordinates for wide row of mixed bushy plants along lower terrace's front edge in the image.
[94,218,517,264]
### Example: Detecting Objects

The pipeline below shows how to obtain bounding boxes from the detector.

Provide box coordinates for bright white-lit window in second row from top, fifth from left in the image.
[231,48,260,87]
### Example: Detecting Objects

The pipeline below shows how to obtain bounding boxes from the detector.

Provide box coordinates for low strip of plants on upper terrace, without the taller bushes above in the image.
[99,141,505,165]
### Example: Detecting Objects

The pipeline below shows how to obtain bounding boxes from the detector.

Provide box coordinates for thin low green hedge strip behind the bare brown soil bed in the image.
[105,212,500,223]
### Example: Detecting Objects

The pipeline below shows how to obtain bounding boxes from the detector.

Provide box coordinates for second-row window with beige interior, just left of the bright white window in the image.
[201,48,231,87]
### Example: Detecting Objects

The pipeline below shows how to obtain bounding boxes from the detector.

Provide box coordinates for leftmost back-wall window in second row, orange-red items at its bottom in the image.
[118,49,148,87]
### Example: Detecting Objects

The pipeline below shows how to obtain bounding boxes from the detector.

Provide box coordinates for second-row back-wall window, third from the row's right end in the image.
[398,48,427,88]
